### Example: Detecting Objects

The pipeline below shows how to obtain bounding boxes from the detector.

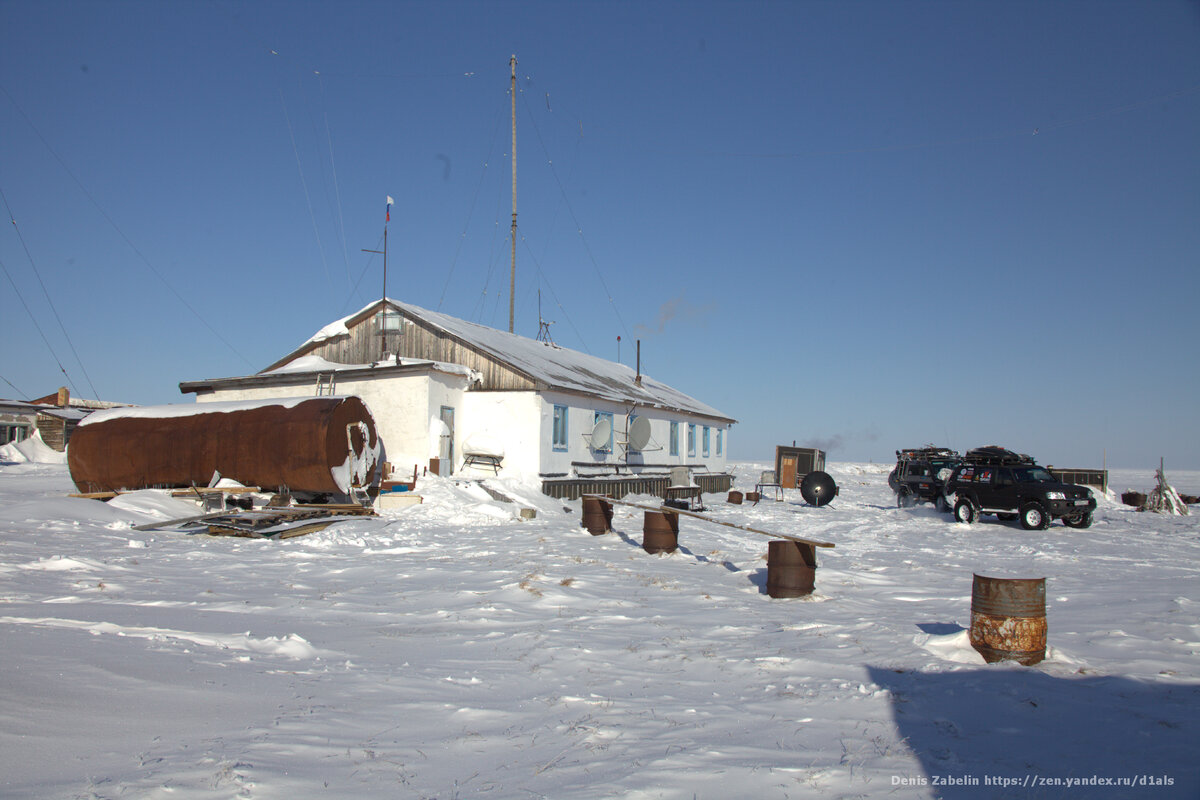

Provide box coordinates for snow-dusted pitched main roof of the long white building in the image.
[295,297,736,422]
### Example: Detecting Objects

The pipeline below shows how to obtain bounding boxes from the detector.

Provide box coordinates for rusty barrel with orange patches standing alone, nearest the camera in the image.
[971,575,1046,667]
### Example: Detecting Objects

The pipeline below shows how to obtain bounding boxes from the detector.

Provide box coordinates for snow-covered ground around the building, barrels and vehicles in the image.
[0,463,1200,799]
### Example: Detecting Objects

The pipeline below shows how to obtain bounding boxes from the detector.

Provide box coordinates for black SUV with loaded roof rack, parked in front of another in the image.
[946,447,1096,530]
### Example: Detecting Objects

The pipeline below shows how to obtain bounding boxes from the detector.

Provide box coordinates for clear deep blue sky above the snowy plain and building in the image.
[0,0,1200,469]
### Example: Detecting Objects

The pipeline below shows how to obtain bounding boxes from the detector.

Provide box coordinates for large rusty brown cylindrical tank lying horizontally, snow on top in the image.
[67,397,380,494]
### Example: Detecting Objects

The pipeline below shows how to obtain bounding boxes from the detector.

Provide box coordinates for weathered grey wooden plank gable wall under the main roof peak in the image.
[304,313,545,391]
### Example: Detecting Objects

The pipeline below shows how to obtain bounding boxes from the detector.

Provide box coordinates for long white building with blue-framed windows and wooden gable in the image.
[180,300,736,495]
